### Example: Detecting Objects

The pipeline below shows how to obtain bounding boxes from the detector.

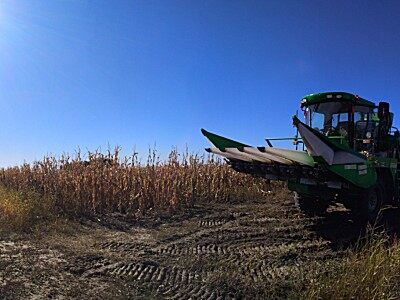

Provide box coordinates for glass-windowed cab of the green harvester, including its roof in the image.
[301,93,398,158]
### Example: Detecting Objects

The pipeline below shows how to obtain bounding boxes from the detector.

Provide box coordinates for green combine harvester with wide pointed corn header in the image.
[202,92,400,222]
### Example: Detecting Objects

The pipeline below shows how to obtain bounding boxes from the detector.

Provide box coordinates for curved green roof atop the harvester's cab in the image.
[301,92,377,108]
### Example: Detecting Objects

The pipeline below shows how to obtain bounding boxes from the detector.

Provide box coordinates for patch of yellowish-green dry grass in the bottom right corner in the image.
[303,236,400,299]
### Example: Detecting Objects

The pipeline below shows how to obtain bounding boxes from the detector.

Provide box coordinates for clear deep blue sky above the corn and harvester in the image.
[0,0,400,166]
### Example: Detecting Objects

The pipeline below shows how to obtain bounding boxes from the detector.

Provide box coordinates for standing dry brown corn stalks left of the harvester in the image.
[0,148,269,216]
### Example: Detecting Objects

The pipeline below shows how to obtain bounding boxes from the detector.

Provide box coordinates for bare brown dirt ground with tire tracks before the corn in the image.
[0,192,384,299]
